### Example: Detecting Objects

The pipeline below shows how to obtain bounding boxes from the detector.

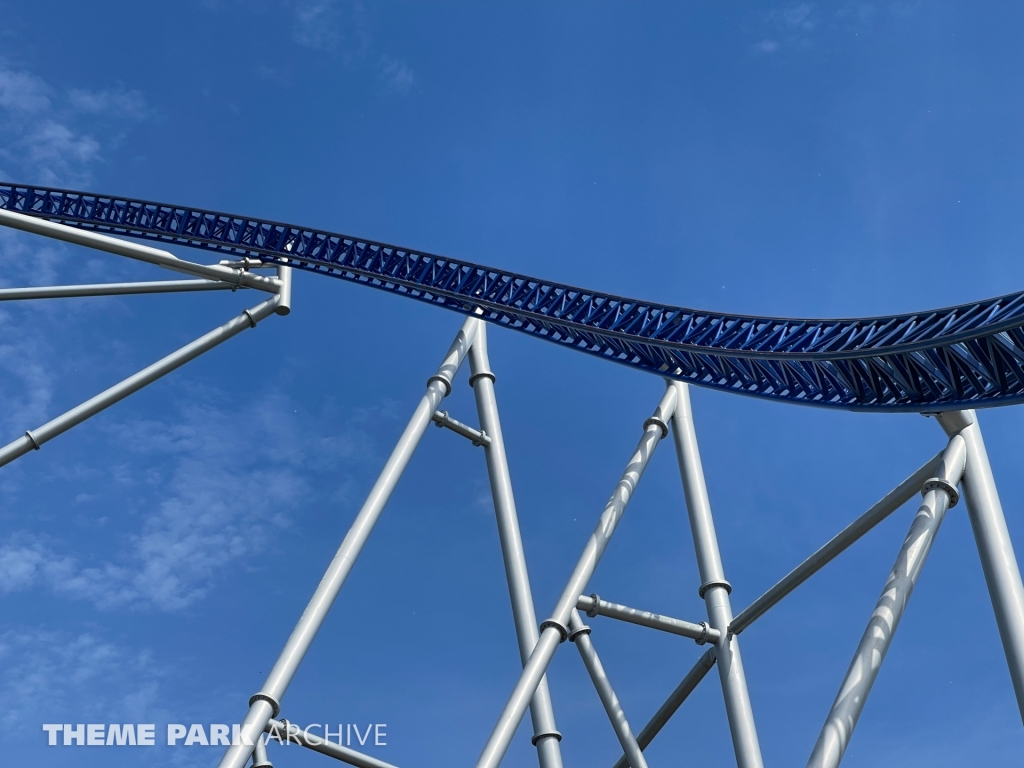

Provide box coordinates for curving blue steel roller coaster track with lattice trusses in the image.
[0,183,1024,412]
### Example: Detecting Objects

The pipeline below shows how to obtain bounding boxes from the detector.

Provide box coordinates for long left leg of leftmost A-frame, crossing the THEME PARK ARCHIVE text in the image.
[218,318,476,768]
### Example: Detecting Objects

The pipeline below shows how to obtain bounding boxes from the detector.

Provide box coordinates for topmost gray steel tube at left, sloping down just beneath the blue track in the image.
[0,210,280,293]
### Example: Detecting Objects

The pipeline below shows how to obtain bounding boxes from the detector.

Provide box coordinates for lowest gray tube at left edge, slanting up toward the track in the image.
[0,296,278,467]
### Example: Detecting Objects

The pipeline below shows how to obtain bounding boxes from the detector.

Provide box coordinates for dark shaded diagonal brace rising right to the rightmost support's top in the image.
[729,453,942,635]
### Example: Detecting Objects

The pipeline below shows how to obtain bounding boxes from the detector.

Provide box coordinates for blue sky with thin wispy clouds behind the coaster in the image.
[0,0,1024,768]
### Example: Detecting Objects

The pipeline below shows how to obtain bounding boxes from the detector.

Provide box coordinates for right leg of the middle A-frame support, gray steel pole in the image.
[671,382,764,768]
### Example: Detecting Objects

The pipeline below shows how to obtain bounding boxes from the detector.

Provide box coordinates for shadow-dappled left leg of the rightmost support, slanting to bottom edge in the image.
[807,435,967,768]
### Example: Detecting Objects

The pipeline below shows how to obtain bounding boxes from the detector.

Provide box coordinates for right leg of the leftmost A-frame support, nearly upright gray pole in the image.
[469,319,562,768]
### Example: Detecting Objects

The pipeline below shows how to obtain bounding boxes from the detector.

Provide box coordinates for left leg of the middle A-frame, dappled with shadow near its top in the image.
[473,386,678,768]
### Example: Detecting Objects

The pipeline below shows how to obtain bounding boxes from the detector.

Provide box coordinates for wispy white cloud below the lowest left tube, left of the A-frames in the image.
[0,393,372,611]
